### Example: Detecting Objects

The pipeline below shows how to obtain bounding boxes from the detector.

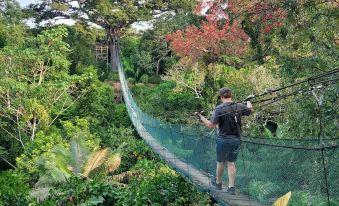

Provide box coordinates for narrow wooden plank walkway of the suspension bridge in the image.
[118,56,262,206]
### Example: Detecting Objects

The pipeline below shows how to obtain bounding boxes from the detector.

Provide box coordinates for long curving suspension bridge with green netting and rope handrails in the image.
[115,43,339,206]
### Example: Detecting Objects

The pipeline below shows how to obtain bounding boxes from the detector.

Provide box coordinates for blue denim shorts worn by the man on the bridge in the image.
[216,137,240,162]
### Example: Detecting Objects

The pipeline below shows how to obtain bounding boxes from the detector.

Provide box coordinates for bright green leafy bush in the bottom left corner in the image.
[0,170,30,206]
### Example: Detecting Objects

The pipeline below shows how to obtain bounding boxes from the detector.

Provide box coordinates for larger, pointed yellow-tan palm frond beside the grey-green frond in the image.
[83,148,108,177]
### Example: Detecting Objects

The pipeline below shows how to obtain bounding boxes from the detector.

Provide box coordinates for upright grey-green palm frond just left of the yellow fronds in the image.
[71,139,89,174]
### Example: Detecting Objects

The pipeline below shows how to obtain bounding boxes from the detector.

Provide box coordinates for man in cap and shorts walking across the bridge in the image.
[195,87,254,195]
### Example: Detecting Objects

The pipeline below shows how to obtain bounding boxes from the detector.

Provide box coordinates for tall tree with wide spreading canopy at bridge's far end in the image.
[30,0,194,71]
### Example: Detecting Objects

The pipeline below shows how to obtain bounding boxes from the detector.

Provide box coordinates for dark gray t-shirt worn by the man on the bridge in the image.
[210,102,251,138]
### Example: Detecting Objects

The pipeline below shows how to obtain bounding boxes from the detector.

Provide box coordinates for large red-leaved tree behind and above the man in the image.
[166,1,249,62]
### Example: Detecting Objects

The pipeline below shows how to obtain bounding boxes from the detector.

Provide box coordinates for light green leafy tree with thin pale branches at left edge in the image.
[0,27,90,151]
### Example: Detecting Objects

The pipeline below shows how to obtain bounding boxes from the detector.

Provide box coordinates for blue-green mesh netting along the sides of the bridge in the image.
[116,46,339,206]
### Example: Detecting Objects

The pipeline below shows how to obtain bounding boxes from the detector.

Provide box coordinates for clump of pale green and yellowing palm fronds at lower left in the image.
[31,137,124,202]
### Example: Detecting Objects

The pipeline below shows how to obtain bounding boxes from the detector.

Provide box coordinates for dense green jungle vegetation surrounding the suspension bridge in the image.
[0,0,339,206]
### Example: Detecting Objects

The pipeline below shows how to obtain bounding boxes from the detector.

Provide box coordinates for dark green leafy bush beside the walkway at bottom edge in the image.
[117,160,209,205]
